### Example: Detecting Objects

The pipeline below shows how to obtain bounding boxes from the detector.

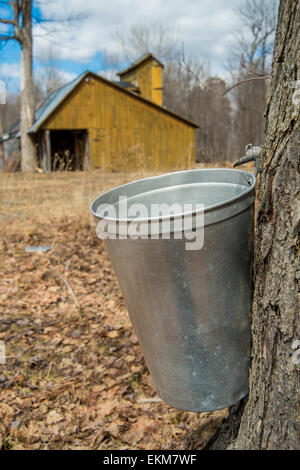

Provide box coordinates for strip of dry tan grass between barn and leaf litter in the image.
[0,162,241,232]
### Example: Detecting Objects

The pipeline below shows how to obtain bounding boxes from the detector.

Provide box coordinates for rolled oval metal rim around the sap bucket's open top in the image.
[90,168,256,223]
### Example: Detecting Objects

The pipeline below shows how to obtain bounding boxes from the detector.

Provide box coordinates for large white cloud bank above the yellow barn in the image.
[34,0,240,68]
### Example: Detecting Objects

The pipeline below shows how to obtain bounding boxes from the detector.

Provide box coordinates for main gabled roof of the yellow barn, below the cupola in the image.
[27,70,199,134]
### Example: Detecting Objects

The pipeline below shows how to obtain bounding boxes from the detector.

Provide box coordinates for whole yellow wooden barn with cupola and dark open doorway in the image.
[28,53,198,171]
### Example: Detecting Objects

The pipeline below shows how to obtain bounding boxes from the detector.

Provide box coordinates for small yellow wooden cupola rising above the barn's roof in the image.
[117,52,163,106]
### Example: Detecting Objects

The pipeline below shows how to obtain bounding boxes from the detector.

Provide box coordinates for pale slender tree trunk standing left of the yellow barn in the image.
[20,0,37,172]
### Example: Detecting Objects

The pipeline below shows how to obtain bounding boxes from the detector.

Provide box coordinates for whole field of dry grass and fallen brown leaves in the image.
[0,164,243,449]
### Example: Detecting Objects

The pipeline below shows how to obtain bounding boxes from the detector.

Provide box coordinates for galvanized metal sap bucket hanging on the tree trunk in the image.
[91,169,255,411]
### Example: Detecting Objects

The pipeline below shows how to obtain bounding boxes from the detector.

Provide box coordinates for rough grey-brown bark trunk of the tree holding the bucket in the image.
[206,0,300,449]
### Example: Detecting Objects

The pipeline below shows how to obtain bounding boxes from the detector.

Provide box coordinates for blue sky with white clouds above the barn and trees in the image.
[0,0,268,90]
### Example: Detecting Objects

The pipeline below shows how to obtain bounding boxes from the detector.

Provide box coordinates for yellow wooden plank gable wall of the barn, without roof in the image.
[43,79,195,170]
